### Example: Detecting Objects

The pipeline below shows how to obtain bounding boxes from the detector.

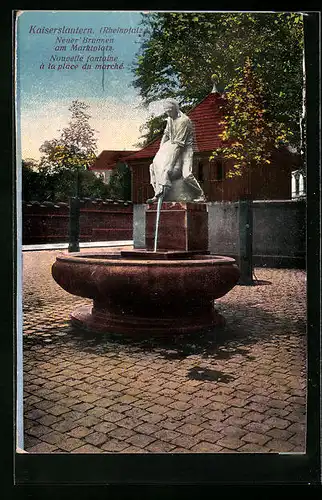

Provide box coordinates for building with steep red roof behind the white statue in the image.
[123,87,297,204]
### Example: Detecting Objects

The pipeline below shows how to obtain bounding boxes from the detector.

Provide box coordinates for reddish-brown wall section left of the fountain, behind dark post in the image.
[22,199,133,245]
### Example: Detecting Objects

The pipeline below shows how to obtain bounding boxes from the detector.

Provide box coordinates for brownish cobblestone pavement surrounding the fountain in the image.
[23,250,306,453]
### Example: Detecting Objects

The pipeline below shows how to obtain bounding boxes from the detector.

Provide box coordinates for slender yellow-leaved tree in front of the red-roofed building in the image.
[211,58,287,177]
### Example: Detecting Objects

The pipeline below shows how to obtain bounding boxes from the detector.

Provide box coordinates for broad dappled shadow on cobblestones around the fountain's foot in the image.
[24,298,306,366]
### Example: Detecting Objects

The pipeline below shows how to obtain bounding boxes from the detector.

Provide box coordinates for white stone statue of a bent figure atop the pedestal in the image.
[147,99,206,203]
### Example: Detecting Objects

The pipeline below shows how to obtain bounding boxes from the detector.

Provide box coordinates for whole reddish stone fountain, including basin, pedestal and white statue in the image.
[52,99,240,335]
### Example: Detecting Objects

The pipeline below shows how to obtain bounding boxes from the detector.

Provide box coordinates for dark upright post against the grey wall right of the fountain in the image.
[238,200,254,285]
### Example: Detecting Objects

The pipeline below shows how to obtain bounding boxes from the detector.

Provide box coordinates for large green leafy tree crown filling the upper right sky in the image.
[133,12,303,146]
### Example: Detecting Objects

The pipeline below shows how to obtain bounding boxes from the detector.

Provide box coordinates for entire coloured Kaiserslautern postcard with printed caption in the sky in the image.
[15,10,320,484]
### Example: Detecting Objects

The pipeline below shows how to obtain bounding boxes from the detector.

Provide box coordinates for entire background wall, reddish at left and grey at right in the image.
[22,200,306,268]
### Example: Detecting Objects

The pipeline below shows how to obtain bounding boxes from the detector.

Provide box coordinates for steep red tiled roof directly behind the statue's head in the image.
[124,92,224,162]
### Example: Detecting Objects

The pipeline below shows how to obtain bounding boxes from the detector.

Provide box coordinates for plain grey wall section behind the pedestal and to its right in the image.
[133,200,306,268]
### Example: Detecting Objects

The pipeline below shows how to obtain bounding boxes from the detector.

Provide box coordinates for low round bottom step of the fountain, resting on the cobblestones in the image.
[70,306,225,336]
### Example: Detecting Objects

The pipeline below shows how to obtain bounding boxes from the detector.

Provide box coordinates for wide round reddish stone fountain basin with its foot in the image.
[52,251,240,333]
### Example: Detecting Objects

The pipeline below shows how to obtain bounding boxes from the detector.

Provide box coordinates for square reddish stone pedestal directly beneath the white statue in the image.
[145,202,208,252]
